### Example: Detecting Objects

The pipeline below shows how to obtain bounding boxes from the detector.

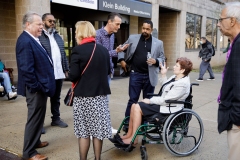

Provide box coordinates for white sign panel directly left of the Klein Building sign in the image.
[52,0,98,9]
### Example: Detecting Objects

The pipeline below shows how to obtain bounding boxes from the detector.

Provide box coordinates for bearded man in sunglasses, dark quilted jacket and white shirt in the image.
[39,13,69,133]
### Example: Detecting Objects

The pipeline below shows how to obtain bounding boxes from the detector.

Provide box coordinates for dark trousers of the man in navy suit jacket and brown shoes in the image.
[23,89,47,158]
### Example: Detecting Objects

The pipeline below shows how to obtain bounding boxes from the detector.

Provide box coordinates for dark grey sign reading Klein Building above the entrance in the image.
[98,0,152,18]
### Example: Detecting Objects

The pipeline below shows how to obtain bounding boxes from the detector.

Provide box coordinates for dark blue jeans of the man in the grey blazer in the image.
[125,72,155,117]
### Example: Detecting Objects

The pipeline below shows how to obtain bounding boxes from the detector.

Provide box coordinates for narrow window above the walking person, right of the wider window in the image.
[206,18,217,48]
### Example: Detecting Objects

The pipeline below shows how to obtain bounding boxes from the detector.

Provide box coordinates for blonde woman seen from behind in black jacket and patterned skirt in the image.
[69,21,112,160]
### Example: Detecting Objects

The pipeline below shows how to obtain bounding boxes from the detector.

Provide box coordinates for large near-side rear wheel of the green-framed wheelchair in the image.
[163,109,203,156]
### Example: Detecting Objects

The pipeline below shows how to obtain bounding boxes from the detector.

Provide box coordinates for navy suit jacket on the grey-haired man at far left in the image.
[16,31,55,97]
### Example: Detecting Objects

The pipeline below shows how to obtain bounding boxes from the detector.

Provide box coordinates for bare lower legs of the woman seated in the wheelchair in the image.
[123,104,142,144]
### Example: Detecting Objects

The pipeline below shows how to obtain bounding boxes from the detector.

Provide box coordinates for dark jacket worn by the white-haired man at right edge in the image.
[218,34,240,133]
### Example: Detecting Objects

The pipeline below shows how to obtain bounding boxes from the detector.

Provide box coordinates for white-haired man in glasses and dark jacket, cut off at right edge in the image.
[217,2,240,160]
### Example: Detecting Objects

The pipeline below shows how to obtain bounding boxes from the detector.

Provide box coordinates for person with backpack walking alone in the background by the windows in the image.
[196,37,215,81]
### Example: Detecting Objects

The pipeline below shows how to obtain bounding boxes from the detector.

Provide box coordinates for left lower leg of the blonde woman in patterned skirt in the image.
[78,137,90,160]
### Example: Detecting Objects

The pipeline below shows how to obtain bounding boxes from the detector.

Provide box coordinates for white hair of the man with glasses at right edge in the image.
[224,2,240,23]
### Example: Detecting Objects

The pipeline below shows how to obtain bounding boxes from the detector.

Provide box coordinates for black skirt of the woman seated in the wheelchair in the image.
[138,102,160,116]
